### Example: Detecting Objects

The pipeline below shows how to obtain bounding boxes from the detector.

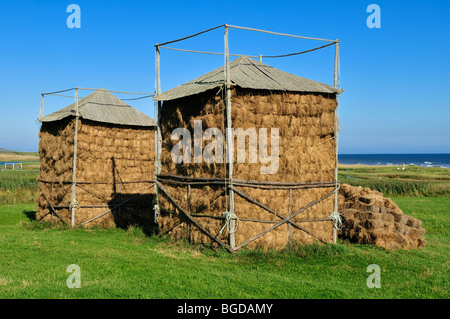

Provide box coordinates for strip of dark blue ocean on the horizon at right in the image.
[338,154,450,168]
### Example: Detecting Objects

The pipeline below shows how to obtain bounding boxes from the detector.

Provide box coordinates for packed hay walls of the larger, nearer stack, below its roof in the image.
[159,88,337,249]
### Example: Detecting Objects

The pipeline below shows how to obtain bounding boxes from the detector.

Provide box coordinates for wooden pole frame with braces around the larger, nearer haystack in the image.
[155,24,340,252]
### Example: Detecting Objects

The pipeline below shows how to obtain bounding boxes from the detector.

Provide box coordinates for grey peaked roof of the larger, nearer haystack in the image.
[155,56,341,101]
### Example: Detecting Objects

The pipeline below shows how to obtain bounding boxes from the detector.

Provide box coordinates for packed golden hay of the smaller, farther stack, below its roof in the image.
[36,118,155,227]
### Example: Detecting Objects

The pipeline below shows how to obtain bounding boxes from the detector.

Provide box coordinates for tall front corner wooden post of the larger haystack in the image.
[224,25,236,249]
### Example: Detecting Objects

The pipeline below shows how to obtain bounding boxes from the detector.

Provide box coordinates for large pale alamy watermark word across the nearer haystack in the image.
[171,120,279,174]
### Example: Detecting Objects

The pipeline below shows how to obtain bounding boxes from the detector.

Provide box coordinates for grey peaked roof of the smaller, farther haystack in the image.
[40,89,156,126]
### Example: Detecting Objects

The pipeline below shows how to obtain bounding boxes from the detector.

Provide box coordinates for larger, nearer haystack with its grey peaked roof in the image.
[155,56,341,250]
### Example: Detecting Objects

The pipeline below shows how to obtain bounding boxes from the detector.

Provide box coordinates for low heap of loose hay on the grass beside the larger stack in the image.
[339,184,425,250]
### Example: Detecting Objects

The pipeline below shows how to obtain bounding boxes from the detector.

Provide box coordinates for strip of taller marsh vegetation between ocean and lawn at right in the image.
[338,165,450,197]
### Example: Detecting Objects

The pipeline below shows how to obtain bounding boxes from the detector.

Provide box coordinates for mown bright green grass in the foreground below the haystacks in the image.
[0,197,450,299]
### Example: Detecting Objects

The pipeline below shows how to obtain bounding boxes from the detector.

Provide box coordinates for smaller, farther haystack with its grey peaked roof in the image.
[36,89,156,229]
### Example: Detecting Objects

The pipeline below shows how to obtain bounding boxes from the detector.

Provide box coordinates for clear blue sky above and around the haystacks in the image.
[0,0,450,153]
